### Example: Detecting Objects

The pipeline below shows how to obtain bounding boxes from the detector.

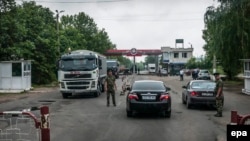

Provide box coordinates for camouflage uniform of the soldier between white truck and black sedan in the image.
[105,75,116,106]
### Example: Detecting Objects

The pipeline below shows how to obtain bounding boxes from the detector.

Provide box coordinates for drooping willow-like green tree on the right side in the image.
[203,0,250,79]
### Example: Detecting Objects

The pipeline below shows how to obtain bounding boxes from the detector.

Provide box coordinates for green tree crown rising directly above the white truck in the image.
[60,12,116,54]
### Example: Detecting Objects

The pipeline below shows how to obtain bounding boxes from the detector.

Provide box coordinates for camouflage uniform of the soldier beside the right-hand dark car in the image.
[215,79,223,116]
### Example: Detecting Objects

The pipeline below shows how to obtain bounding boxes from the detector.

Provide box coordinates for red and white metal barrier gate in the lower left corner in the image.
[0,106,50,141]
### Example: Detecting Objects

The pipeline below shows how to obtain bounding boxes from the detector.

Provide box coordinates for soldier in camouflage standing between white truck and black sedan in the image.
[104,70,117,106]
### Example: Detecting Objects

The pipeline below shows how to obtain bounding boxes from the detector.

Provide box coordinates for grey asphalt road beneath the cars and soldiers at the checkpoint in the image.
[0,75,250,141]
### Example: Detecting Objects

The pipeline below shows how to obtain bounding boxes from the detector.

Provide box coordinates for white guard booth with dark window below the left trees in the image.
[0,60,31,93]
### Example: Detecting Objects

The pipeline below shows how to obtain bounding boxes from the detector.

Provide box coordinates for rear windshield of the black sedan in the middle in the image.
[132,82,165,90]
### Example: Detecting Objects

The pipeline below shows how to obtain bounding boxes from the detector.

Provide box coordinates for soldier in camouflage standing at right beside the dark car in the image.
[214,73,223,117]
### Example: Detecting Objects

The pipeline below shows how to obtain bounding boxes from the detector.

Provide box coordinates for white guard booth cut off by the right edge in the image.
[242,59,250,95]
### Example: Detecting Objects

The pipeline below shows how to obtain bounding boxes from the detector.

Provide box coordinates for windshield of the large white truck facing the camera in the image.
[59,58,97,71]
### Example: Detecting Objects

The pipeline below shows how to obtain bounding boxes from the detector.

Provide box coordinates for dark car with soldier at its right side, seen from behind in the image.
[182,80,224,109]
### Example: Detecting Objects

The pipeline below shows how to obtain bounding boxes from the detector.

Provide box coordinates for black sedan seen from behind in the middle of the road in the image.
[126,80,171,118]
